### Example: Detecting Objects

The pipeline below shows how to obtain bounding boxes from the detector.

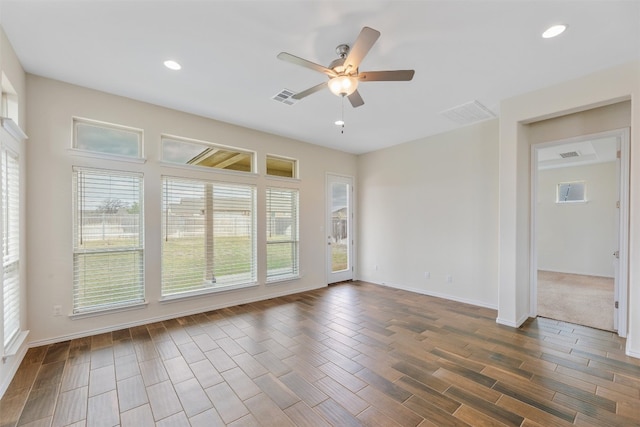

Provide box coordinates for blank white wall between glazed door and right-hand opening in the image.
[358,120,498,307]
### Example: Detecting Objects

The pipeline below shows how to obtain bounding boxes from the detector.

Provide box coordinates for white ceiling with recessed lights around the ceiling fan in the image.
[0,0,640,153]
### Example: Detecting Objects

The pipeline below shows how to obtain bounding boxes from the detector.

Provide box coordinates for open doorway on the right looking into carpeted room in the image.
[531,129,629,337]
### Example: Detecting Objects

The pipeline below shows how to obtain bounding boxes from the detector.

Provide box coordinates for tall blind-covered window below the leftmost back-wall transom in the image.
[73,168,144,314]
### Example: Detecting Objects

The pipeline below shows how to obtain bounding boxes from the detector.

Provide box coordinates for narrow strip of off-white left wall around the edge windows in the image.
[0,27,28,396]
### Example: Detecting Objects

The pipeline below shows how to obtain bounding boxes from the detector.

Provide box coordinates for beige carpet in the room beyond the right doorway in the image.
[538,270,614,331]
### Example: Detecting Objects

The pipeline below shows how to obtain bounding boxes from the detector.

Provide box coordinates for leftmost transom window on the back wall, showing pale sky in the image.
[73,119,142,158]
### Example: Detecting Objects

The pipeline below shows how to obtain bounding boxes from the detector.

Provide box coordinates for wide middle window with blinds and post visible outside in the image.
[162,177,257,296]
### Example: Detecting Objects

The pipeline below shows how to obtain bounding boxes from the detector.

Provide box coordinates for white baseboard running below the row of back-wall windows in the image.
[28,285,326,348]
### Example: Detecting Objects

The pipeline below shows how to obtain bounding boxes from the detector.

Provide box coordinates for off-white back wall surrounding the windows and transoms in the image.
[27,75,356,344]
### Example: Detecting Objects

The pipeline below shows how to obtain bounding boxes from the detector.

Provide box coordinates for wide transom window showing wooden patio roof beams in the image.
[162,137,254,172]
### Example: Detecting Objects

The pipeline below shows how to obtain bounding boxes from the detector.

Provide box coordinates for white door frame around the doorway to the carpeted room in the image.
[529,127,630,338]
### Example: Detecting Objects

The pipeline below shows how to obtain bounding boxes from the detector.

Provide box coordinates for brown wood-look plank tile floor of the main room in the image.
[0,282,640,427]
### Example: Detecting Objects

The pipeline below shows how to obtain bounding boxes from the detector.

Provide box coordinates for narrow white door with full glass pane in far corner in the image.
[326,174,353,283]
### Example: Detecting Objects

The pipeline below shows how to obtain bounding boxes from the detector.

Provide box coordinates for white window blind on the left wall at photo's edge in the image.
[1,147,20,349]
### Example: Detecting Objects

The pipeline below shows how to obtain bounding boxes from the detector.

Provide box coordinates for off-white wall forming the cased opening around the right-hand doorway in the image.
[498,61,640,357]
